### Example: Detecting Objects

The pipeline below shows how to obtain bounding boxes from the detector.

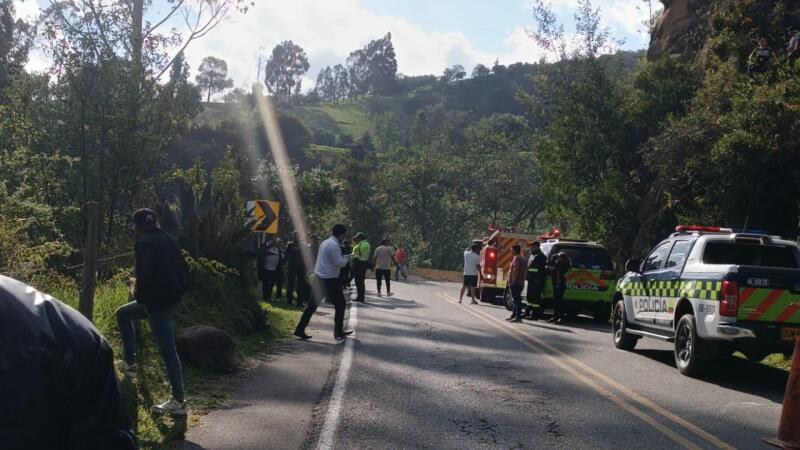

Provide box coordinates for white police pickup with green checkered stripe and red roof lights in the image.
[612,225,800,375]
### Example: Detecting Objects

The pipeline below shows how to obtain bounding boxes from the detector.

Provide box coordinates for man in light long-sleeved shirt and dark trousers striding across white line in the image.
[294,224,353,340]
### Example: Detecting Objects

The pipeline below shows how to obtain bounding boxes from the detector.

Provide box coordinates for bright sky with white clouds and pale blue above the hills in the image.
[15,0,660,95]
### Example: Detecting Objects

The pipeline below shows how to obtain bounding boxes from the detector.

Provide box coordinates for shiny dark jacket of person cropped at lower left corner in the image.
[0,275,138,450]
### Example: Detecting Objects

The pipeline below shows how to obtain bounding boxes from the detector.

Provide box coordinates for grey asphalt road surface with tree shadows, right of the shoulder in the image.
[304,281,787,449]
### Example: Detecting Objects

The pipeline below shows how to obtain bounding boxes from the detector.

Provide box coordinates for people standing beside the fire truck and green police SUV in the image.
[458,241,572,323]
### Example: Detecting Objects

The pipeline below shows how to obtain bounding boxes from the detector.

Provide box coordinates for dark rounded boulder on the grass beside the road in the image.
[176,325,236,372]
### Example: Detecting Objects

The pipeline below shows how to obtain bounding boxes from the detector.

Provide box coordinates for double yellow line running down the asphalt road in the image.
[439,293,735,450]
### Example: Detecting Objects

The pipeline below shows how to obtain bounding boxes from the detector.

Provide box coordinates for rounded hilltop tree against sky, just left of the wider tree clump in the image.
[264,41,309,103]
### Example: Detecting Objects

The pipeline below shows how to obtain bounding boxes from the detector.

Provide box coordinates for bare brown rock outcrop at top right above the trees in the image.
[647,0,712,61]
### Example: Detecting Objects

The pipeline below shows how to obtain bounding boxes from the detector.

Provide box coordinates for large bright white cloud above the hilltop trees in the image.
[180,0,556,93]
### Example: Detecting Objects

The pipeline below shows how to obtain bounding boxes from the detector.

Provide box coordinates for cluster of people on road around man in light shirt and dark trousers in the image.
[290,224,408,340]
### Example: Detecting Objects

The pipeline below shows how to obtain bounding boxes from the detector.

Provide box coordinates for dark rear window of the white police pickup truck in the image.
[703,242,798,269]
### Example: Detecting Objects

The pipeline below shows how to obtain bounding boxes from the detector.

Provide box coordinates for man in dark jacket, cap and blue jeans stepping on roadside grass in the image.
[117,209,188,414]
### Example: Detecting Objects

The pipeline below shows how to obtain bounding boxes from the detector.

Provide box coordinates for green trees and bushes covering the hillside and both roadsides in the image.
[0,0,800,448]
